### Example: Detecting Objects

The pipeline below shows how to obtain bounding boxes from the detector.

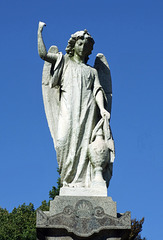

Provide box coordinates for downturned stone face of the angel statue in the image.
[74,39,90,59]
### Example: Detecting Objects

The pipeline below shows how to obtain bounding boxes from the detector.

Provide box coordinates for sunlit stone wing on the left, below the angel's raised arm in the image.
[42,46,63,146]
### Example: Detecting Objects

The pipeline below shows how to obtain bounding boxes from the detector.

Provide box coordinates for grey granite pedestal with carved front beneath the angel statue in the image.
[37,196,131,240]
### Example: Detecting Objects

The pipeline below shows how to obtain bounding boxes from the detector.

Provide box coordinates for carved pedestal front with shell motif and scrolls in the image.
[37,199,131,240]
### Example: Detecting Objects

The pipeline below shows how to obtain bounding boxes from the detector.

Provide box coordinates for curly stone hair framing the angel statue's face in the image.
[66,29,95,63]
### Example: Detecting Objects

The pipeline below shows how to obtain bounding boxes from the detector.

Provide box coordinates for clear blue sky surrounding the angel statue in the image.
[0,0,163,240]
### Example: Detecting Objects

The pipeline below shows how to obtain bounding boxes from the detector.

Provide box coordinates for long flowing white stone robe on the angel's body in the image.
[50,56,101,187]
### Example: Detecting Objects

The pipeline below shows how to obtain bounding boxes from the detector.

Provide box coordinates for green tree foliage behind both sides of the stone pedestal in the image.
[0,175,146,240]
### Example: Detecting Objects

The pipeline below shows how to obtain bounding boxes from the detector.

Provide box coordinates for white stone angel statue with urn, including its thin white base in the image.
[38,22,115,196]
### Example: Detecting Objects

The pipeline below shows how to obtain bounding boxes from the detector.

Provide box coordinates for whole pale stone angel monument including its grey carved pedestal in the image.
[37,22,131,240]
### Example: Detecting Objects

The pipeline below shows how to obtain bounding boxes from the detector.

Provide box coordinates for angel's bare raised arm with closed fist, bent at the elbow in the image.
[38,22,58,63]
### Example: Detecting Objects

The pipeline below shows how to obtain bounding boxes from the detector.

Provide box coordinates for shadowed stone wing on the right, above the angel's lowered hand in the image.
[94,53,112,114]
